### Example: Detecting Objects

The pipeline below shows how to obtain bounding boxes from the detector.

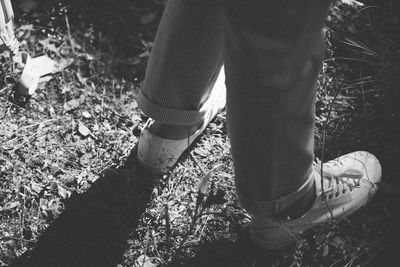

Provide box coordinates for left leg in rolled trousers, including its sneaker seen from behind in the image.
[137,0,226,173]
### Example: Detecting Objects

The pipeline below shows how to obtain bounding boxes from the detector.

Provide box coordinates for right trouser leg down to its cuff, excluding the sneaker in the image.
[225,0,330,218]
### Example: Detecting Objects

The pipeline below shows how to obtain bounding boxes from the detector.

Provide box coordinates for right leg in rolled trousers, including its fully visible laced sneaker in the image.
[224,0,382,249]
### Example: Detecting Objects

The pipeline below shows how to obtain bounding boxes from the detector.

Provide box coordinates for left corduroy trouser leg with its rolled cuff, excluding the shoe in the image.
[137,0,223,130]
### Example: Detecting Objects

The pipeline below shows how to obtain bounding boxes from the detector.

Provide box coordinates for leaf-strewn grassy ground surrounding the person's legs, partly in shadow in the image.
[0,0,400,267]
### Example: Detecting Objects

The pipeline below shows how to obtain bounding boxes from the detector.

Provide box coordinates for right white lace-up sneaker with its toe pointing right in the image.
[250,151,382,249]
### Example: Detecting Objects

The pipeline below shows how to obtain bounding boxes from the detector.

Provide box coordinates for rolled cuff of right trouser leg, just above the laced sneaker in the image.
[238,171,314,218]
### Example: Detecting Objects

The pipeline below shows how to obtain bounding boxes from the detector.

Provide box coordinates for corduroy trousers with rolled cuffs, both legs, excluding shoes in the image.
[137,0,330,217]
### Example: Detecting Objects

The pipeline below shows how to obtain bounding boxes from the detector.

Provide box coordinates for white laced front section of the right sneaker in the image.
[314,159,364,200]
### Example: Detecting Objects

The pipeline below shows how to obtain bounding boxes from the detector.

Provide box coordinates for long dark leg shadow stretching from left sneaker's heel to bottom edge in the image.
[11,149,154,267]
